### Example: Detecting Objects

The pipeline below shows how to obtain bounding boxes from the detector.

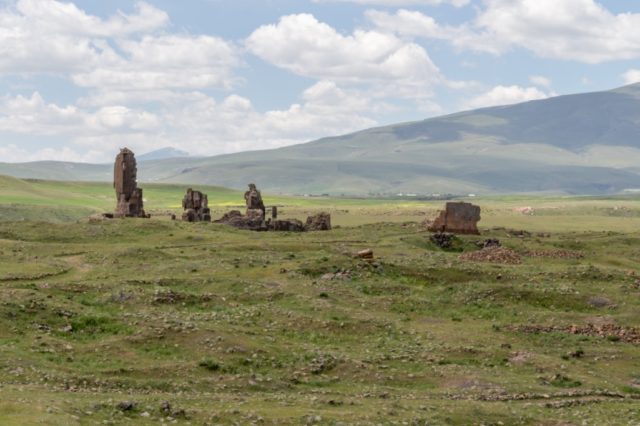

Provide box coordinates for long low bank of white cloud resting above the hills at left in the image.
[0,81,386,161]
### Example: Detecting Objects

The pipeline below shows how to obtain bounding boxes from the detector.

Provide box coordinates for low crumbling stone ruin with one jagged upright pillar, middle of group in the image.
[215,183,331,232]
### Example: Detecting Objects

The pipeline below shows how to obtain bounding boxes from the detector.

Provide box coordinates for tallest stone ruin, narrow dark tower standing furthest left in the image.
[113,148,148,217]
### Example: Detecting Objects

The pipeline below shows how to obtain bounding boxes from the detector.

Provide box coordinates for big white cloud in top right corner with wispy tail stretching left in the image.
[367,0,640,64]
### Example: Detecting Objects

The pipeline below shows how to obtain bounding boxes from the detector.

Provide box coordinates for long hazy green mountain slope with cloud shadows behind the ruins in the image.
[0,84,640,194]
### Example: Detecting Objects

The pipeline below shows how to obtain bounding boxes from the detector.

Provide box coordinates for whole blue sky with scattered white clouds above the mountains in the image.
[0,0,640,163]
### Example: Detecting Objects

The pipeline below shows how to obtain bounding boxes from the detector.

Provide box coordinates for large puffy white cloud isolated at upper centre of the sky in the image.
[246,14,442,95]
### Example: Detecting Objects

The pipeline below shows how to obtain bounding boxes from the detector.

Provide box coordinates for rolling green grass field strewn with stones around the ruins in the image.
[0,178,640,425]
